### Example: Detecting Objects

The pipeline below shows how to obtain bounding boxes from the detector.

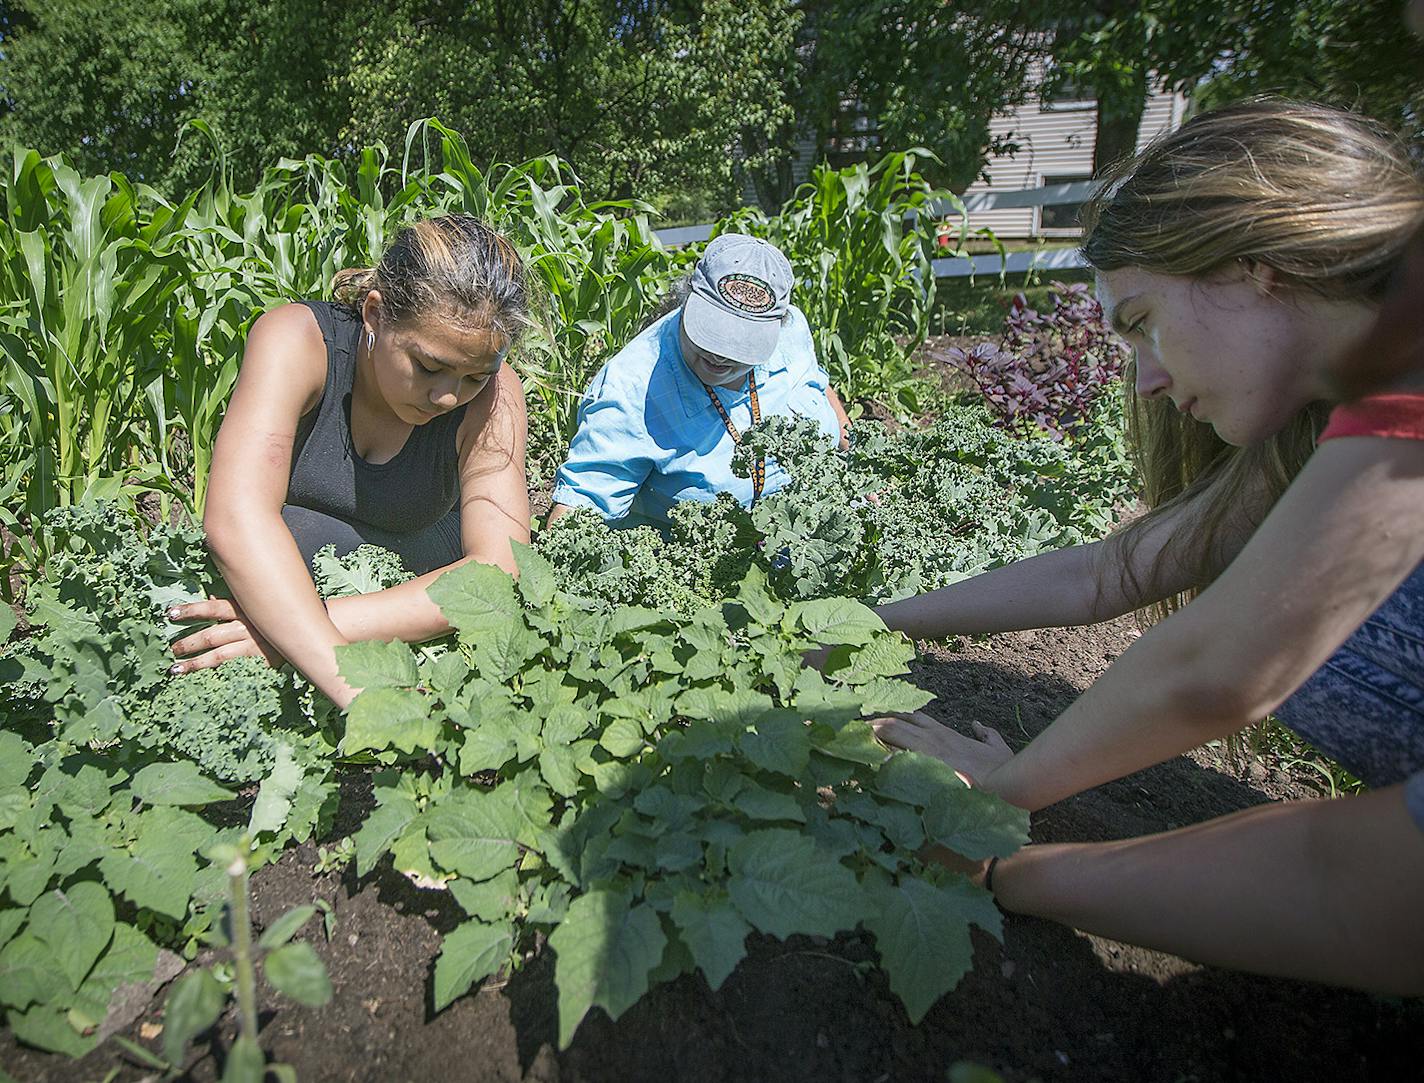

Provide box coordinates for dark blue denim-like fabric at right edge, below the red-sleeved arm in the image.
[1276,564,1424,828]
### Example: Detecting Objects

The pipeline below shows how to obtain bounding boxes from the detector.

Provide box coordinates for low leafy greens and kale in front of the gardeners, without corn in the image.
[0,392,1125,1063]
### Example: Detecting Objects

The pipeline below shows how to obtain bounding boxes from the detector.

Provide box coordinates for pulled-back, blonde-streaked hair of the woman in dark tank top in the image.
[332,215,534,343]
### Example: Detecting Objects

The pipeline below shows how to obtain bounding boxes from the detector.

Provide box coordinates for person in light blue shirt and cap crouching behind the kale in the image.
[550,233,846,527]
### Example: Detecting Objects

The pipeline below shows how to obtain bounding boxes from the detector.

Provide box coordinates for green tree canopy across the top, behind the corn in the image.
[0,0,1424,209]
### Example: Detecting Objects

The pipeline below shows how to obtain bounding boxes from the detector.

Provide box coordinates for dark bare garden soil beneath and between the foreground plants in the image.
[0,620,1424,1083]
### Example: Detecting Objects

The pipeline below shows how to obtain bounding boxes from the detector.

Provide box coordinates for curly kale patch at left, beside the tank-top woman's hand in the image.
[6,504,323,783]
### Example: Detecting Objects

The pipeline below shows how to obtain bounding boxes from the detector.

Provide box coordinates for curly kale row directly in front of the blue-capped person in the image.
[538,404,1132,613]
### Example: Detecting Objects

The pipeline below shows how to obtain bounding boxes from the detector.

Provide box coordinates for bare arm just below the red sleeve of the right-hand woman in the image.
[879,437,1424,808]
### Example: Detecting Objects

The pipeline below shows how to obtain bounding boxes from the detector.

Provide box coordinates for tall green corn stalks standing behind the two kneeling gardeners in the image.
[0,121,974,594]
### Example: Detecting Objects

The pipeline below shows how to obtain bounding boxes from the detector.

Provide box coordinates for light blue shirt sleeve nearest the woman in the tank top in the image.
[553,370,652,521]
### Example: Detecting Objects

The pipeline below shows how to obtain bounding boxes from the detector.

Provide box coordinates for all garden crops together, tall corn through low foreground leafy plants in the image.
[0,122,1131,1080]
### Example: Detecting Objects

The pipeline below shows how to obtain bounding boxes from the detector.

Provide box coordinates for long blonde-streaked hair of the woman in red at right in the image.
[1082,98,1424,609]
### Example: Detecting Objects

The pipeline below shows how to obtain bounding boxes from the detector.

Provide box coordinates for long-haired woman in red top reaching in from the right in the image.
[877,100,1424,993]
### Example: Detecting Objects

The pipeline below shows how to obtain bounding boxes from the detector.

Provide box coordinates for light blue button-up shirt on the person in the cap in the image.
[554,306,840,527]
